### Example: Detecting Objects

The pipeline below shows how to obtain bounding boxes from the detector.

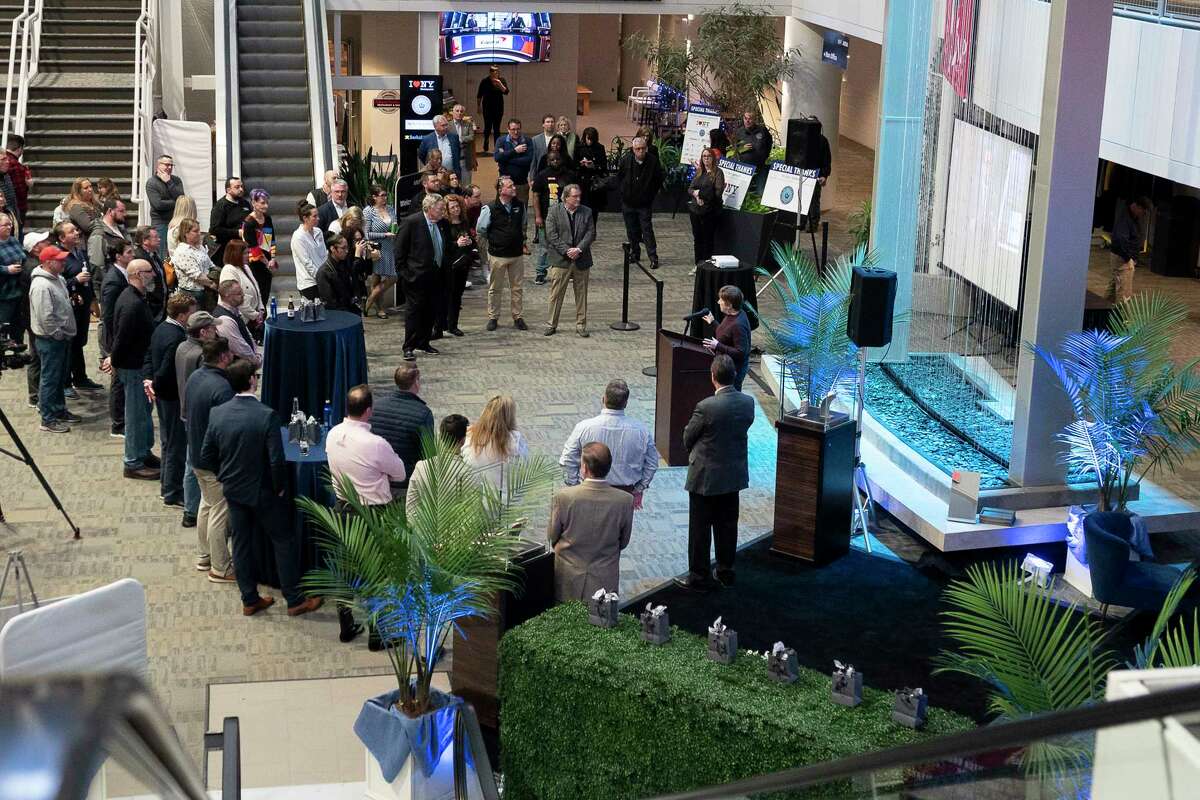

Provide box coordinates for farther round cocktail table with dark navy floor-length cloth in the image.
[262,311,367,425]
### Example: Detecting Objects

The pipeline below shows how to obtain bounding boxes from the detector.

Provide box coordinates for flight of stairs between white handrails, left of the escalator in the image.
[14,0,140,228]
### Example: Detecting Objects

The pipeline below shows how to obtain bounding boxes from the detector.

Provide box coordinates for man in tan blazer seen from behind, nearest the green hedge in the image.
[546,441,634,602]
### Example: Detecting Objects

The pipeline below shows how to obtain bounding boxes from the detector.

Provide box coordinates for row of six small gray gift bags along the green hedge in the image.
[588,589,929,728]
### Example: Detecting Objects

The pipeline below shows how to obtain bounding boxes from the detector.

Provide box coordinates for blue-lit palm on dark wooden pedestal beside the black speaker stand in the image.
[758,243,872,563]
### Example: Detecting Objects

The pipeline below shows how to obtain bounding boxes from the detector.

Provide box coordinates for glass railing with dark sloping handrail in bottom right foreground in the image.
[659,670,1200,800]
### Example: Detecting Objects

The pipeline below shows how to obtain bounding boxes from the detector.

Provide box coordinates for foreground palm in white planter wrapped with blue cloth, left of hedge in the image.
[300,437,558,798]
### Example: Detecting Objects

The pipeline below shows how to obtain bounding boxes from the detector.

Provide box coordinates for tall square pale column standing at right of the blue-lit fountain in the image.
[1008,0,1112,486]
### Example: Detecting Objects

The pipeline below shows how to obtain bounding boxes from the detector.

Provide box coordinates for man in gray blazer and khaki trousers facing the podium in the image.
[545,184,596,338]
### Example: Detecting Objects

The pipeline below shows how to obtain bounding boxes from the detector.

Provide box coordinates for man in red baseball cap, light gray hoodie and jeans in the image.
[29,245,80,433]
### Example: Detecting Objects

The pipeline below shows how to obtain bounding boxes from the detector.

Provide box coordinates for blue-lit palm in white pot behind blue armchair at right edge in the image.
[1030,293,1200,591]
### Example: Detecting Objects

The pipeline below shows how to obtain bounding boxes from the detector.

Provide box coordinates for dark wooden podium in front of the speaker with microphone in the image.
[654,330,713,467]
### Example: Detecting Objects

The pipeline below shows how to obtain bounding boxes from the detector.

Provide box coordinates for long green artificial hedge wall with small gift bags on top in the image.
[499,603,973,800]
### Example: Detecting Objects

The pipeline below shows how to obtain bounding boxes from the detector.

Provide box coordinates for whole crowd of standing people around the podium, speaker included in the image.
[0,95,768,623]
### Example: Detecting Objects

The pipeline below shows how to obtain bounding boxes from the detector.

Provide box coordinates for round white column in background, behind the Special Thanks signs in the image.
[776,17,854,209]
